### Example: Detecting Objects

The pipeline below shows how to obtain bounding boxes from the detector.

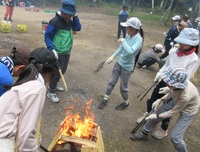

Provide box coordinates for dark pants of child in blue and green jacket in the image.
[49,54,70,91]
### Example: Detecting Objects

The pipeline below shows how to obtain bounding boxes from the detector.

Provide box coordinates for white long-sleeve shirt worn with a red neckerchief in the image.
[159,48,200,80]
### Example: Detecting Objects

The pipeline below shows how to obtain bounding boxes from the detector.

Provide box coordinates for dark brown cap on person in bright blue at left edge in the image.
[9,46,31,66]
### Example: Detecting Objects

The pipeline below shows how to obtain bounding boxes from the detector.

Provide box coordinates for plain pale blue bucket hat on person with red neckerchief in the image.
[174,28,199,46]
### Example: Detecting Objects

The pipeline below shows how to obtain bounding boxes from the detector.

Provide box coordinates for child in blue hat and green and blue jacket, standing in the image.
[44,0,81,103]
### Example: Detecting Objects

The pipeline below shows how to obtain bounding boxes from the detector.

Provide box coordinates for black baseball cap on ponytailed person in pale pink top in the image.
[29,48,57,68]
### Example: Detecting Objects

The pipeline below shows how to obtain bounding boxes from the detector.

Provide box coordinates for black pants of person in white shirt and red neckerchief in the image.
[147,81,170,130]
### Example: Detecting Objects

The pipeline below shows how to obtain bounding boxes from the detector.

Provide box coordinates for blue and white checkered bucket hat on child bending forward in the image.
[160,66,188,89]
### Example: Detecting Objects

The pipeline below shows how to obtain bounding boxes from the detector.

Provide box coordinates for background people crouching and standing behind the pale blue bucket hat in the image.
[138,14,197,72]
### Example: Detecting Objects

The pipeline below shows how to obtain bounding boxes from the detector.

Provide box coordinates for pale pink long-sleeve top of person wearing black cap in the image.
[0,75,46,152]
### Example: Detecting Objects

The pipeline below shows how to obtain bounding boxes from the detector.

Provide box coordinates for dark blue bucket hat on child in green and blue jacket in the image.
[60,0,76,16]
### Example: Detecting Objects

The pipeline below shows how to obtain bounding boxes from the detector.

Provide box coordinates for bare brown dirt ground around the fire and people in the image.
[0,6,200,152]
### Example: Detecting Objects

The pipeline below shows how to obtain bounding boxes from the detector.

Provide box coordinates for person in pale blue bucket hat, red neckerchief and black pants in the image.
[137,28,200,139]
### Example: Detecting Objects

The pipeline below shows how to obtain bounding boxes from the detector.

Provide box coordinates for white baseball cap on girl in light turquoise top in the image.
[121,17,142,30]
